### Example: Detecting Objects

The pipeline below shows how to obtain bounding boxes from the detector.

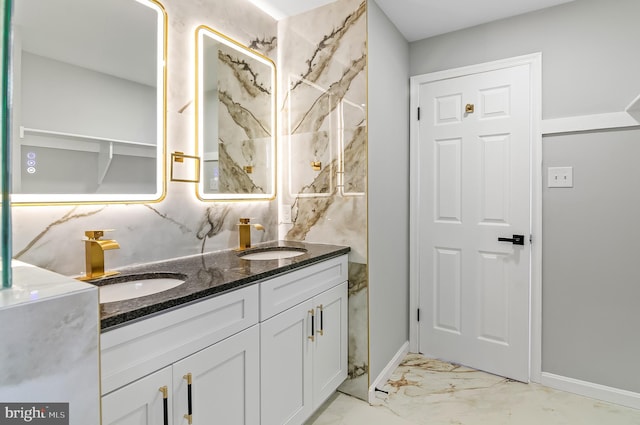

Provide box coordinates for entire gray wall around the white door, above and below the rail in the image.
[410,0,640,392]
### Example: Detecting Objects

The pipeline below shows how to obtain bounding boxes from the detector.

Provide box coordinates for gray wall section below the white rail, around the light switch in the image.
[542,130,640,392]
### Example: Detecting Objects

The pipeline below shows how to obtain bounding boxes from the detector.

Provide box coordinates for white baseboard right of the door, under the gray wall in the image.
[540,372,640,409]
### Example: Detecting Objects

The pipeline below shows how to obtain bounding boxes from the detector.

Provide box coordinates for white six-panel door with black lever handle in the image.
[417,65,531,382]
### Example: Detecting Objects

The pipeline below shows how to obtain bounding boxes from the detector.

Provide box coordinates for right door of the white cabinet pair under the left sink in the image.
[173,325,260,425]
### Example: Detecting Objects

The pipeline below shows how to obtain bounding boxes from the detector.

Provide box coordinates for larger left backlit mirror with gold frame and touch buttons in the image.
[11,0,166,204]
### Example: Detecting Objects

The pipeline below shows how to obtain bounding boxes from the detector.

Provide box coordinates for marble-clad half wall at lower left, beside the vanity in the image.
[0,272,100,425]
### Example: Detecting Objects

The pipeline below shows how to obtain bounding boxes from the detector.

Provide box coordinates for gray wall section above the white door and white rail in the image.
[409,0,640,119]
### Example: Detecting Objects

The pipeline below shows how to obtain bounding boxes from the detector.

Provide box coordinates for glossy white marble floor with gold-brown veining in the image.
[307,354,640,425]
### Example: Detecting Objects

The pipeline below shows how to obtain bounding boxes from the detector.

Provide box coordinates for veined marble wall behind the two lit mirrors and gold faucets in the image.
[12,0,278,275]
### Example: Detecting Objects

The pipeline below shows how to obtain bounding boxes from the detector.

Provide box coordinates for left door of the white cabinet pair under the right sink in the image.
[260,300,314,425]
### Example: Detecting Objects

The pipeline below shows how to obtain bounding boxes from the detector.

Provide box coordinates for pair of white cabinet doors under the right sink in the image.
[260,282,348,425]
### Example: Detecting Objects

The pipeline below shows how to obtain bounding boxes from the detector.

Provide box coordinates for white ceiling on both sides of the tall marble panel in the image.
[250,0,573,41]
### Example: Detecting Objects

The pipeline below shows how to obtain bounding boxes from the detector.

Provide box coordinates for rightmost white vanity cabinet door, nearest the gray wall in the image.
[313,282,348,410]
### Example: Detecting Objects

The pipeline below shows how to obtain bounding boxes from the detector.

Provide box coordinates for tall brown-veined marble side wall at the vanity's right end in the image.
[278,0,369,399]
